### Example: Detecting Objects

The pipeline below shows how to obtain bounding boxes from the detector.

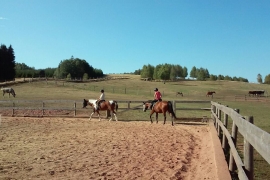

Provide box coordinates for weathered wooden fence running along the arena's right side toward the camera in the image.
[211,102,270,180]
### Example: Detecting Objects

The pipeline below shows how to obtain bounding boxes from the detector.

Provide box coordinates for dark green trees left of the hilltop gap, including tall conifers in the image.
[0,44,104,82]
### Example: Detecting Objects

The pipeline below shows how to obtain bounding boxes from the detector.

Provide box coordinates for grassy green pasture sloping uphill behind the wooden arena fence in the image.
[1,75,270,179]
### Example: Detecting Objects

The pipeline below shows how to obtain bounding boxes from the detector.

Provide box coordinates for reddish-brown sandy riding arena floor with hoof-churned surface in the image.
[0,116,230,180]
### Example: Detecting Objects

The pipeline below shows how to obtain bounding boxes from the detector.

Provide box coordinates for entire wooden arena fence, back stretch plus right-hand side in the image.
[0,100,270,180]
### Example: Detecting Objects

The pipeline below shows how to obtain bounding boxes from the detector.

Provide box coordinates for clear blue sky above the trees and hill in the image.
[0,0,270,82]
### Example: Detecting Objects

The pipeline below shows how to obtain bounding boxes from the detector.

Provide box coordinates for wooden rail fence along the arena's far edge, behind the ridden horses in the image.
[0,100,211,118]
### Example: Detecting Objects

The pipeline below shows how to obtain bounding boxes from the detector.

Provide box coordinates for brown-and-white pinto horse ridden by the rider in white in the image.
[83,99,118,121]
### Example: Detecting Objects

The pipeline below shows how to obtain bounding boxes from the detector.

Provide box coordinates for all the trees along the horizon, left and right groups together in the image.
[0,44,270,84]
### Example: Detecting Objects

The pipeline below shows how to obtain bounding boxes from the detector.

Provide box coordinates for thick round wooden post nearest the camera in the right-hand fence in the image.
[244,116,254,180]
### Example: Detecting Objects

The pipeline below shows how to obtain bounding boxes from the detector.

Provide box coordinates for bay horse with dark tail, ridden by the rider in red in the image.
[143,101,176,126]
